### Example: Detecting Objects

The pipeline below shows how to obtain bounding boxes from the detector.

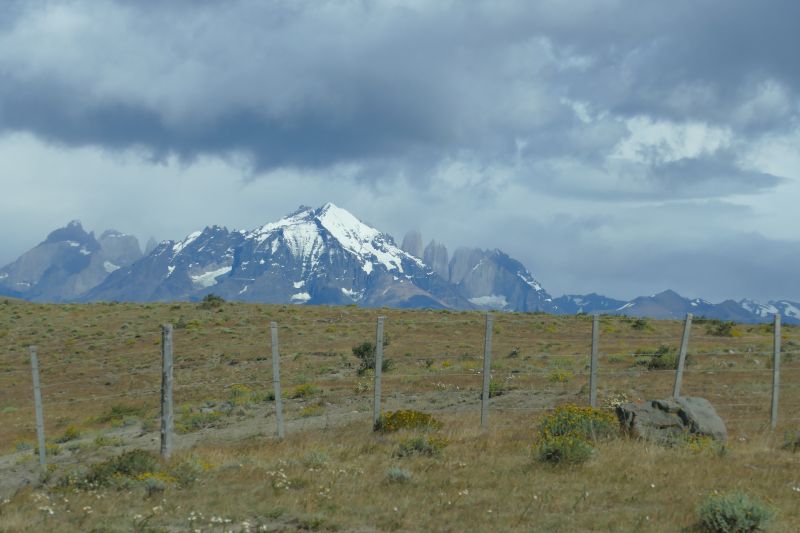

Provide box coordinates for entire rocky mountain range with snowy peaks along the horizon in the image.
[0,203,800,324]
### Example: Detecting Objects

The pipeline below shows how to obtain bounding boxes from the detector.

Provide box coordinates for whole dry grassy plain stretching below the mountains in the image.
[0,300,800,531]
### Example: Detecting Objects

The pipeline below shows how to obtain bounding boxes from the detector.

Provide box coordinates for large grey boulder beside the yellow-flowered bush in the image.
[617,396,728,444]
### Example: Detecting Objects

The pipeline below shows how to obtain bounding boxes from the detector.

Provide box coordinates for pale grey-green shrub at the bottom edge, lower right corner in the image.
[697,492,774,533]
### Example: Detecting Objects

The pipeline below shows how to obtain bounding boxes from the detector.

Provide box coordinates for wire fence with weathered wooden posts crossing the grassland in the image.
[0,313,800,465]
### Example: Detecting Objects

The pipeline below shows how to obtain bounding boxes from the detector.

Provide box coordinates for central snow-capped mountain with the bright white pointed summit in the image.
[85,203,472,308]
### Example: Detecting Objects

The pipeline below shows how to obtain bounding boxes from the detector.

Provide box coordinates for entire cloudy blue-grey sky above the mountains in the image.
[0,0,800,301]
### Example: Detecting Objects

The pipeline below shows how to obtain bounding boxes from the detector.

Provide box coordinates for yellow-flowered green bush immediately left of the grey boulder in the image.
[537,405,618,464]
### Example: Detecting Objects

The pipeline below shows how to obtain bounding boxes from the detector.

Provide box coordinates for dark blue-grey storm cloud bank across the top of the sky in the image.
[0,0,800,198]
